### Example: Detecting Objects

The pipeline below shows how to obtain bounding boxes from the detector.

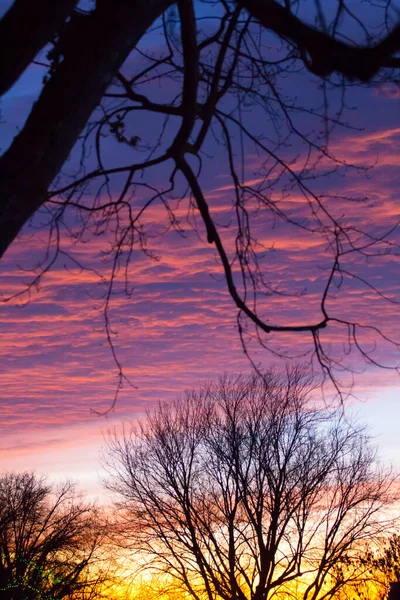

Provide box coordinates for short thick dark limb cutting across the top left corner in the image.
[0,0,77,96]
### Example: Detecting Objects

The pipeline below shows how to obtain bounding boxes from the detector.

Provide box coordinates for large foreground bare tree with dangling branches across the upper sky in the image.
[0,0,400,394]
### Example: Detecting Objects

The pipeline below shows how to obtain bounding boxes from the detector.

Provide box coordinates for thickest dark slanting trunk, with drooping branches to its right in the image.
[0,0,171,256]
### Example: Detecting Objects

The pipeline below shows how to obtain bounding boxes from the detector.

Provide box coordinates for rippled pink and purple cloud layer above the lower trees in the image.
[0,78,400,496]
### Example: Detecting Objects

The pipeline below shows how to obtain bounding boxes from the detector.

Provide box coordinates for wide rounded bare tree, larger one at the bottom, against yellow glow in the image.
[106,369,393,600]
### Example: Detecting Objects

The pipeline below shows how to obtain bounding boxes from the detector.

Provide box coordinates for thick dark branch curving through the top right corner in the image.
[240,0,400,81]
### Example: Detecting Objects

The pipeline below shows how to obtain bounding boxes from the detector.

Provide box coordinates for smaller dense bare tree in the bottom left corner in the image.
[0,473,107,600]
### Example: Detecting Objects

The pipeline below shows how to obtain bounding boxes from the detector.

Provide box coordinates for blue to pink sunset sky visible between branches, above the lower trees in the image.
[0,2,400,499]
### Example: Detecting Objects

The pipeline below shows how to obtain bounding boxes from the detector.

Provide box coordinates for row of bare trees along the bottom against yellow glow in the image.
[0,368,400,600]
